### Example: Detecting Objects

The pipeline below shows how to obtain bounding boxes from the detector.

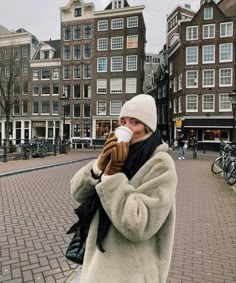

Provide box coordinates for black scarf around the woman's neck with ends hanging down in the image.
[76,130,162,252]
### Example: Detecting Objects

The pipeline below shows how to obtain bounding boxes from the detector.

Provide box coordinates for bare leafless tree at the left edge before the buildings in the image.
[0,46,22,151]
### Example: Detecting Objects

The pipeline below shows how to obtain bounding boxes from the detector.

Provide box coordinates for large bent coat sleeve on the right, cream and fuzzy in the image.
[96,153,177,242]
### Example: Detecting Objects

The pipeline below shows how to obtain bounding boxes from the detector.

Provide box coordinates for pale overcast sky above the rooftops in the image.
[0,0,200,53]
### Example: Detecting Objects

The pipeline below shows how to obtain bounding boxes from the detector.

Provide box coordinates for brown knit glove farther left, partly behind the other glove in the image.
[97,132,117,171]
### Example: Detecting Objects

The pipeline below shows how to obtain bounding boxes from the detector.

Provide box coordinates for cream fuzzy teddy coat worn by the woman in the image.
[71,144,177,283]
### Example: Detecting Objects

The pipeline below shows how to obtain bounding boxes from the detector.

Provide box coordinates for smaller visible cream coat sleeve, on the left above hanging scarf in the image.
[70,160,99,203]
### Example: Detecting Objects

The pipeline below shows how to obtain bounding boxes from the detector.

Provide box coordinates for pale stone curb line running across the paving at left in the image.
[0,157,96,178]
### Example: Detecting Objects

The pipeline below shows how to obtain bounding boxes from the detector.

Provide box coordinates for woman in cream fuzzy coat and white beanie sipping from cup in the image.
[71,94,177,283]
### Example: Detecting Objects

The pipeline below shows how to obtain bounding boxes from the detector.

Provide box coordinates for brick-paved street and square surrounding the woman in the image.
[0,151,236,283]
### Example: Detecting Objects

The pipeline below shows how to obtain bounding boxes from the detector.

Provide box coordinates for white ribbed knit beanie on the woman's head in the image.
[120,94,157,132]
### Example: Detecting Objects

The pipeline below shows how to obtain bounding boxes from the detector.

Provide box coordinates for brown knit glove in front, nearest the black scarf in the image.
[104,142,129,175]
